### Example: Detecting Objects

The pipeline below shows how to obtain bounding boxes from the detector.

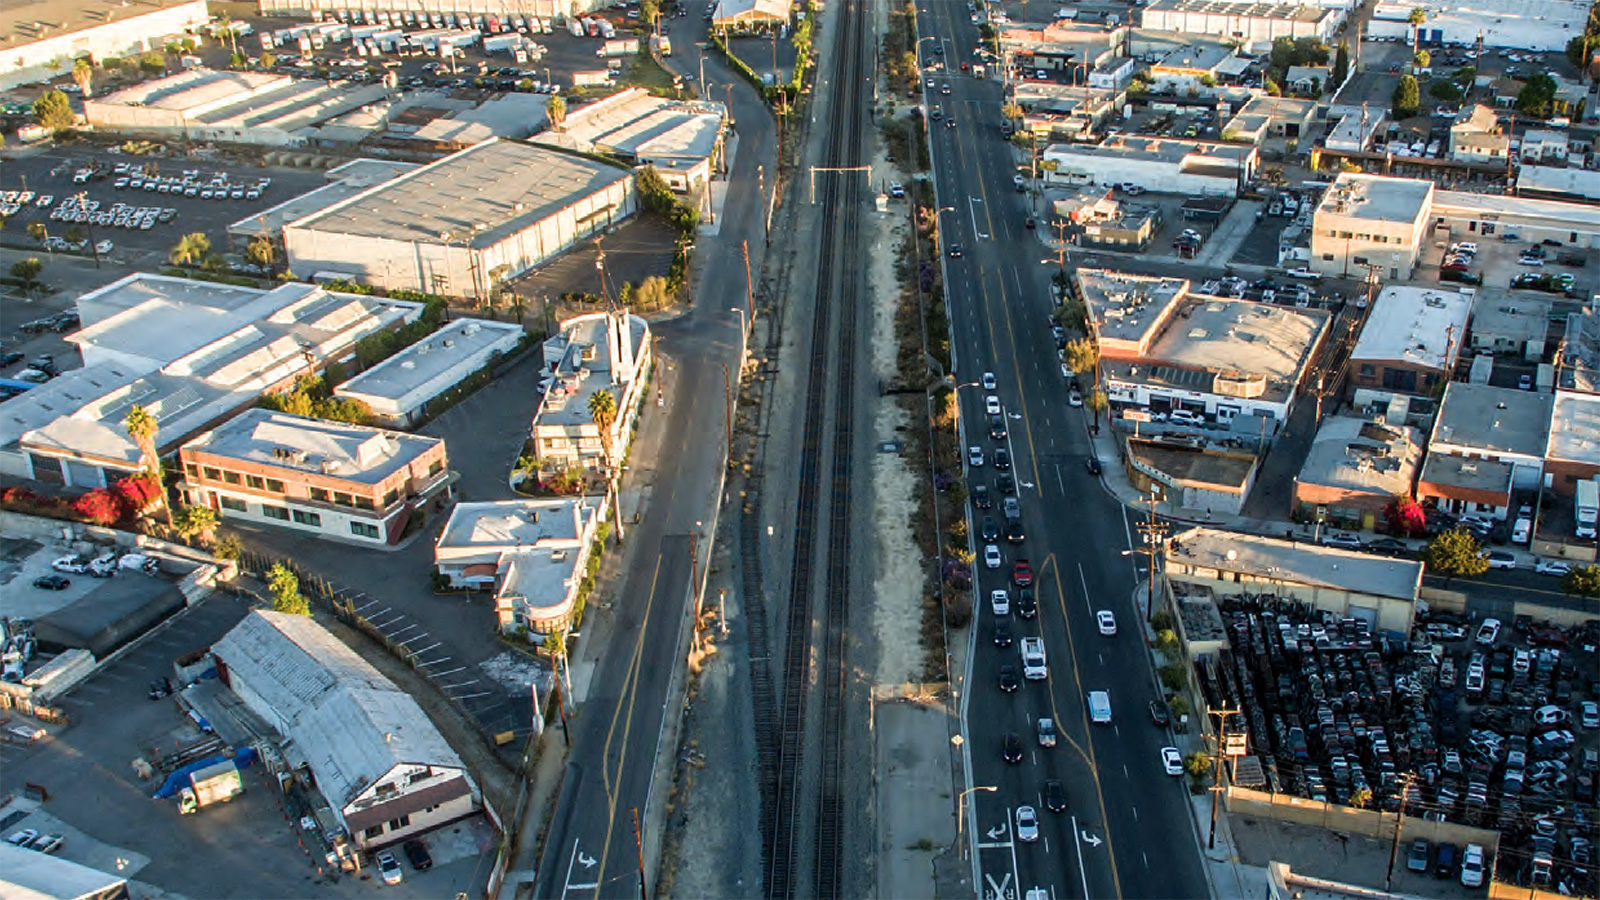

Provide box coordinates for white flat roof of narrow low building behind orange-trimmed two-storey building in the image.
[334,319,523,410]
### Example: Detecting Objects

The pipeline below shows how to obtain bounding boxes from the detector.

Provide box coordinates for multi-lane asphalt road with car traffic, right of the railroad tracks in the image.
[918,3,1210,900]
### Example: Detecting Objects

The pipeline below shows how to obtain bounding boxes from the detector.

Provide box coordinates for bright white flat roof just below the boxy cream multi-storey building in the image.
[1350,285,1472,368]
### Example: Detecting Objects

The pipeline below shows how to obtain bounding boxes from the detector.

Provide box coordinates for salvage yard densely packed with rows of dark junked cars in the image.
[1202,596,1600,895]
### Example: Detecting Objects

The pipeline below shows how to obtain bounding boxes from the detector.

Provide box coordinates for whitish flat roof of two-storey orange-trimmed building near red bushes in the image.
[184,408,443,484]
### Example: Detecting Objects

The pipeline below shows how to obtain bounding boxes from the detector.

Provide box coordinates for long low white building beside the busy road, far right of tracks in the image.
[1043,135,1256,197]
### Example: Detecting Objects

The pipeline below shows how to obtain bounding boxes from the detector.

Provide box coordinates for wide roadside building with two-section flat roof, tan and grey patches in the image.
[1077,269,1330,425]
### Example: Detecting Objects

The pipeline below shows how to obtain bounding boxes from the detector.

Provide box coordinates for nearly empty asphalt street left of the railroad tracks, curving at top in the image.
[528,5,776,898]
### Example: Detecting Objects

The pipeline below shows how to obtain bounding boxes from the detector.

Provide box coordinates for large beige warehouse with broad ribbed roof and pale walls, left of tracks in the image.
[283,139,637,299]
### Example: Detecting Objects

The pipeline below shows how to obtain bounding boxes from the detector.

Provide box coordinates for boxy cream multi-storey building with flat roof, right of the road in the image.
[1310,171,1434,280]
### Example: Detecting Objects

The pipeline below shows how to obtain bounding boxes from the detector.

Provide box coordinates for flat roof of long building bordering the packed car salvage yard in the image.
[1166,528,1422,601]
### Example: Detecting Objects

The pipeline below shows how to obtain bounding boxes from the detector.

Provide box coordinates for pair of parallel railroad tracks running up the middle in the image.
[766,0,867,900]
